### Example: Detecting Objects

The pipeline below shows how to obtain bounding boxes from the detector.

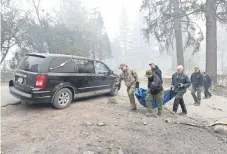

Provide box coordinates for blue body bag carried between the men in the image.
[135,88,176,108]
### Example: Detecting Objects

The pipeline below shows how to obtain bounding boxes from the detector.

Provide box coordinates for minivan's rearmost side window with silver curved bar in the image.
[49,57,75,73]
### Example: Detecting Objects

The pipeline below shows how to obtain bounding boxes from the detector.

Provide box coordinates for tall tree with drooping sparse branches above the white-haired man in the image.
[141,0,204,65]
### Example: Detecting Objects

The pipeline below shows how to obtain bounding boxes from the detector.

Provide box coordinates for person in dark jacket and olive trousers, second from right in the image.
[191,67,203,106]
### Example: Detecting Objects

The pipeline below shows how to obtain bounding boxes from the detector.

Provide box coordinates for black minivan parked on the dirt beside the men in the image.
[9,53,118,109]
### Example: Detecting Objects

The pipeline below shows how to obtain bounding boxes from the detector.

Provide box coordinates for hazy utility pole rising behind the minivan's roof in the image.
[90,7,100,60]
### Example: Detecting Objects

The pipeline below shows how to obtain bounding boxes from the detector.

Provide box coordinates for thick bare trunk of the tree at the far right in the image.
[206,0,217,83]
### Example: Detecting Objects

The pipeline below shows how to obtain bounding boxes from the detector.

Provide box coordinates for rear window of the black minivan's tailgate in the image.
[17,56,45,72]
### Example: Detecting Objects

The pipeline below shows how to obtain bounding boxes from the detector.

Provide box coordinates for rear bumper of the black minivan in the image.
[9,80,52,103]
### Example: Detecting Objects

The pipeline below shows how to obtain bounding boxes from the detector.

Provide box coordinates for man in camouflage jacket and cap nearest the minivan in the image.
[117,64,138,110]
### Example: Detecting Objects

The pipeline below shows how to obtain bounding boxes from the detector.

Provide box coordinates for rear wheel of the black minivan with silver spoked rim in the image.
[52,88,72,109]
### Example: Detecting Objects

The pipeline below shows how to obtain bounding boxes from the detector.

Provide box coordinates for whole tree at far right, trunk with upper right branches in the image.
[204,0,227,83]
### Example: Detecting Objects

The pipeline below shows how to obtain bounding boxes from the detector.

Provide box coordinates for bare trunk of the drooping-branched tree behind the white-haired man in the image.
[173,0,184,66]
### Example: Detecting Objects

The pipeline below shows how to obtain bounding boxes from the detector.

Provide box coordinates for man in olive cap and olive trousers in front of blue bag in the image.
[145,70,165,116]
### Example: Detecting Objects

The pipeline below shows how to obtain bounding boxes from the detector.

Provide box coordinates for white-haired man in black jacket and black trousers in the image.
[171,65,190,115]
